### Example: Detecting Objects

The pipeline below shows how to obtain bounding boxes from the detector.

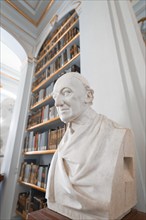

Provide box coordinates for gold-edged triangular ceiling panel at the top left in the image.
[5,0,54,27]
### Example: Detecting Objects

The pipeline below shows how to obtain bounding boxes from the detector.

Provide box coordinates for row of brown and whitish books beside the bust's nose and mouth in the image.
[27,105,58,128]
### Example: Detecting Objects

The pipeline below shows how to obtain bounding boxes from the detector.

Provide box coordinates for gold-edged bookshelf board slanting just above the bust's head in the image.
[32,53,80,92]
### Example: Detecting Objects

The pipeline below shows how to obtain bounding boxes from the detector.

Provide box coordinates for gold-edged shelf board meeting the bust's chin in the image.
[27,117,63,131]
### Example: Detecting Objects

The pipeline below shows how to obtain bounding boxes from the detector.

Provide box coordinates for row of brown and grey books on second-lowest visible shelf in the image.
[19,161,50,189]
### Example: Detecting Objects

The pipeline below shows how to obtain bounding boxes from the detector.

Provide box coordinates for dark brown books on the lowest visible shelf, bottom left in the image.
[16,189,47,219]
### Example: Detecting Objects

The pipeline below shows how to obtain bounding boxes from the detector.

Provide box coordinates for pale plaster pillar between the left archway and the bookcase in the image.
[0,59,34,219]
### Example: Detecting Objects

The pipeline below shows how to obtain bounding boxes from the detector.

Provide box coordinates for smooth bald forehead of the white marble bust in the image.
[53,76,84,92]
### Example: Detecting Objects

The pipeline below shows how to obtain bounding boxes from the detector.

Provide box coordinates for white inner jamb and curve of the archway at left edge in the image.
[0,26,28,219]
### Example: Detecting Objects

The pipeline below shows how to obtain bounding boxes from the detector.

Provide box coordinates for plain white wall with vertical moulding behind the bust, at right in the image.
[80,0,146,212]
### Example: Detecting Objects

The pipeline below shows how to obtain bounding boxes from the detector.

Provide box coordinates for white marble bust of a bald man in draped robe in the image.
[46,72,136,220]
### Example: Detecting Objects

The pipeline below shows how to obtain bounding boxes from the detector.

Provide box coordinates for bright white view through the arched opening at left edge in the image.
[0,27,27,166]
